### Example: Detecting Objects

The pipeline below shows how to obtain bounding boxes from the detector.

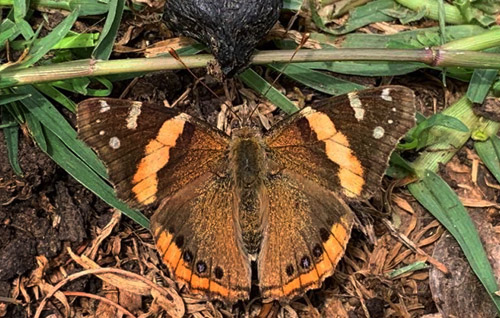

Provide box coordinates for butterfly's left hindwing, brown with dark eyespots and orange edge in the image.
[151,175,251,303]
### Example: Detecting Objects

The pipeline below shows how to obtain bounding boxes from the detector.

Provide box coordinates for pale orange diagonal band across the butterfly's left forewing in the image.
[132,114,186,204]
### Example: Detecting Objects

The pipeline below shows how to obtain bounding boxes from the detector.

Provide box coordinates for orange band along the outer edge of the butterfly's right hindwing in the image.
[280,223,349,298]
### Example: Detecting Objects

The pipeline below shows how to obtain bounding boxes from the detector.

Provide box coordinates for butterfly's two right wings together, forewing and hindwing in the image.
[258,86,415,300]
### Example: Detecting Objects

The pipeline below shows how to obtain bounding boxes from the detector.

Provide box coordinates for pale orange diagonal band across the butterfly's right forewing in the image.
[306,111,365,197]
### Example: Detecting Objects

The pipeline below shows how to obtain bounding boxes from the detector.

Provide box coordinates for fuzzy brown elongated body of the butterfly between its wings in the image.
[230,128,266,255]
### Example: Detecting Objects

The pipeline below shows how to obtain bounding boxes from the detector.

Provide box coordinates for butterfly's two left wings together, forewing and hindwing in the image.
[77,98,251,302]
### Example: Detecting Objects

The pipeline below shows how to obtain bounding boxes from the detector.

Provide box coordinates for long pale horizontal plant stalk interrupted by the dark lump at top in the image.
[0,48,500,88]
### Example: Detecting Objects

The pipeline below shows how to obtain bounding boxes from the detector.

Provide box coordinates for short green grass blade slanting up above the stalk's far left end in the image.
[8,9,79,68]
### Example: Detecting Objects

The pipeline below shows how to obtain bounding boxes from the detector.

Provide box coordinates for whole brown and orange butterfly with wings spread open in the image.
[77,86,415,303]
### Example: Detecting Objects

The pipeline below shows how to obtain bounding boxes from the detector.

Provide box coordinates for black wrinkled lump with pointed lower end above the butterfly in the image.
[163,0,283,77]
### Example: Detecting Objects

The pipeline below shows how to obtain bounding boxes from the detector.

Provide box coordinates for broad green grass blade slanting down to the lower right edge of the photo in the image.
[408,170,500,312]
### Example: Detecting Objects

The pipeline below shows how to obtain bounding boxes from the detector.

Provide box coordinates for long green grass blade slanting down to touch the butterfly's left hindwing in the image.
[35,125,149,228]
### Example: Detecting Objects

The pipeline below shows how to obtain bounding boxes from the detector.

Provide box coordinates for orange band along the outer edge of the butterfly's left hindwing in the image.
[155,230,232,298]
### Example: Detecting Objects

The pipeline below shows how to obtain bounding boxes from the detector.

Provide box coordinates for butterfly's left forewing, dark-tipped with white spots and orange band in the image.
[77,98,229,207]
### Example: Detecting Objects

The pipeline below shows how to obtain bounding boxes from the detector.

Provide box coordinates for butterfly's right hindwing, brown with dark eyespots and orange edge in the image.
[258,171,353,302]
